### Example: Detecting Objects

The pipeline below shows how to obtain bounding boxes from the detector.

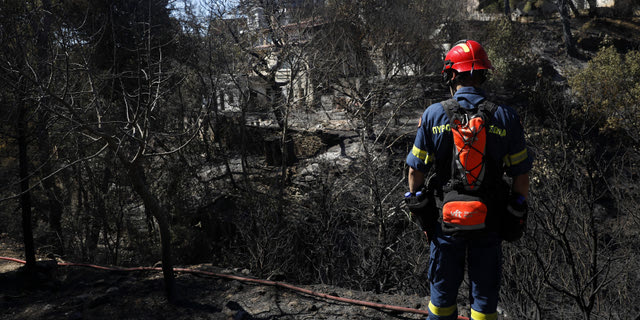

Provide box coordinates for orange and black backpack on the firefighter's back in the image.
[441,99,508,234]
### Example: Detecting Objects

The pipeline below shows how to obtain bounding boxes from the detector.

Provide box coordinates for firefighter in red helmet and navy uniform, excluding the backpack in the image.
[405,40,533,320]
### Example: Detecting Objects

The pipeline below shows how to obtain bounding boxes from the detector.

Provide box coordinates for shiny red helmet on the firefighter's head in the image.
[442,40,493,73]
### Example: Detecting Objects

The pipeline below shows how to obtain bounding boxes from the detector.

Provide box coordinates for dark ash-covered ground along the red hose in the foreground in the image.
[0,235,436,320]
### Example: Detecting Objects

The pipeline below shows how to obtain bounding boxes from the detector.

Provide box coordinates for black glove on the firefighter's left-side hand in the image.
[404,188,438,239]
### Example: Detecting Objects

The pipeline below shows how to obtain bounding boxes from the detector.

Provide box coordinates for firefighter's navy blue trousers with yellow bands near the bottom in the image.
[427,228,502,320]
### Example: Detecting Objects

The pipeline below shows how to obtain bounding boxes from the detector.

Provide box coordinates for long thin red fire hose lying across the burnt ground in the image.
[0,257,469,320]
